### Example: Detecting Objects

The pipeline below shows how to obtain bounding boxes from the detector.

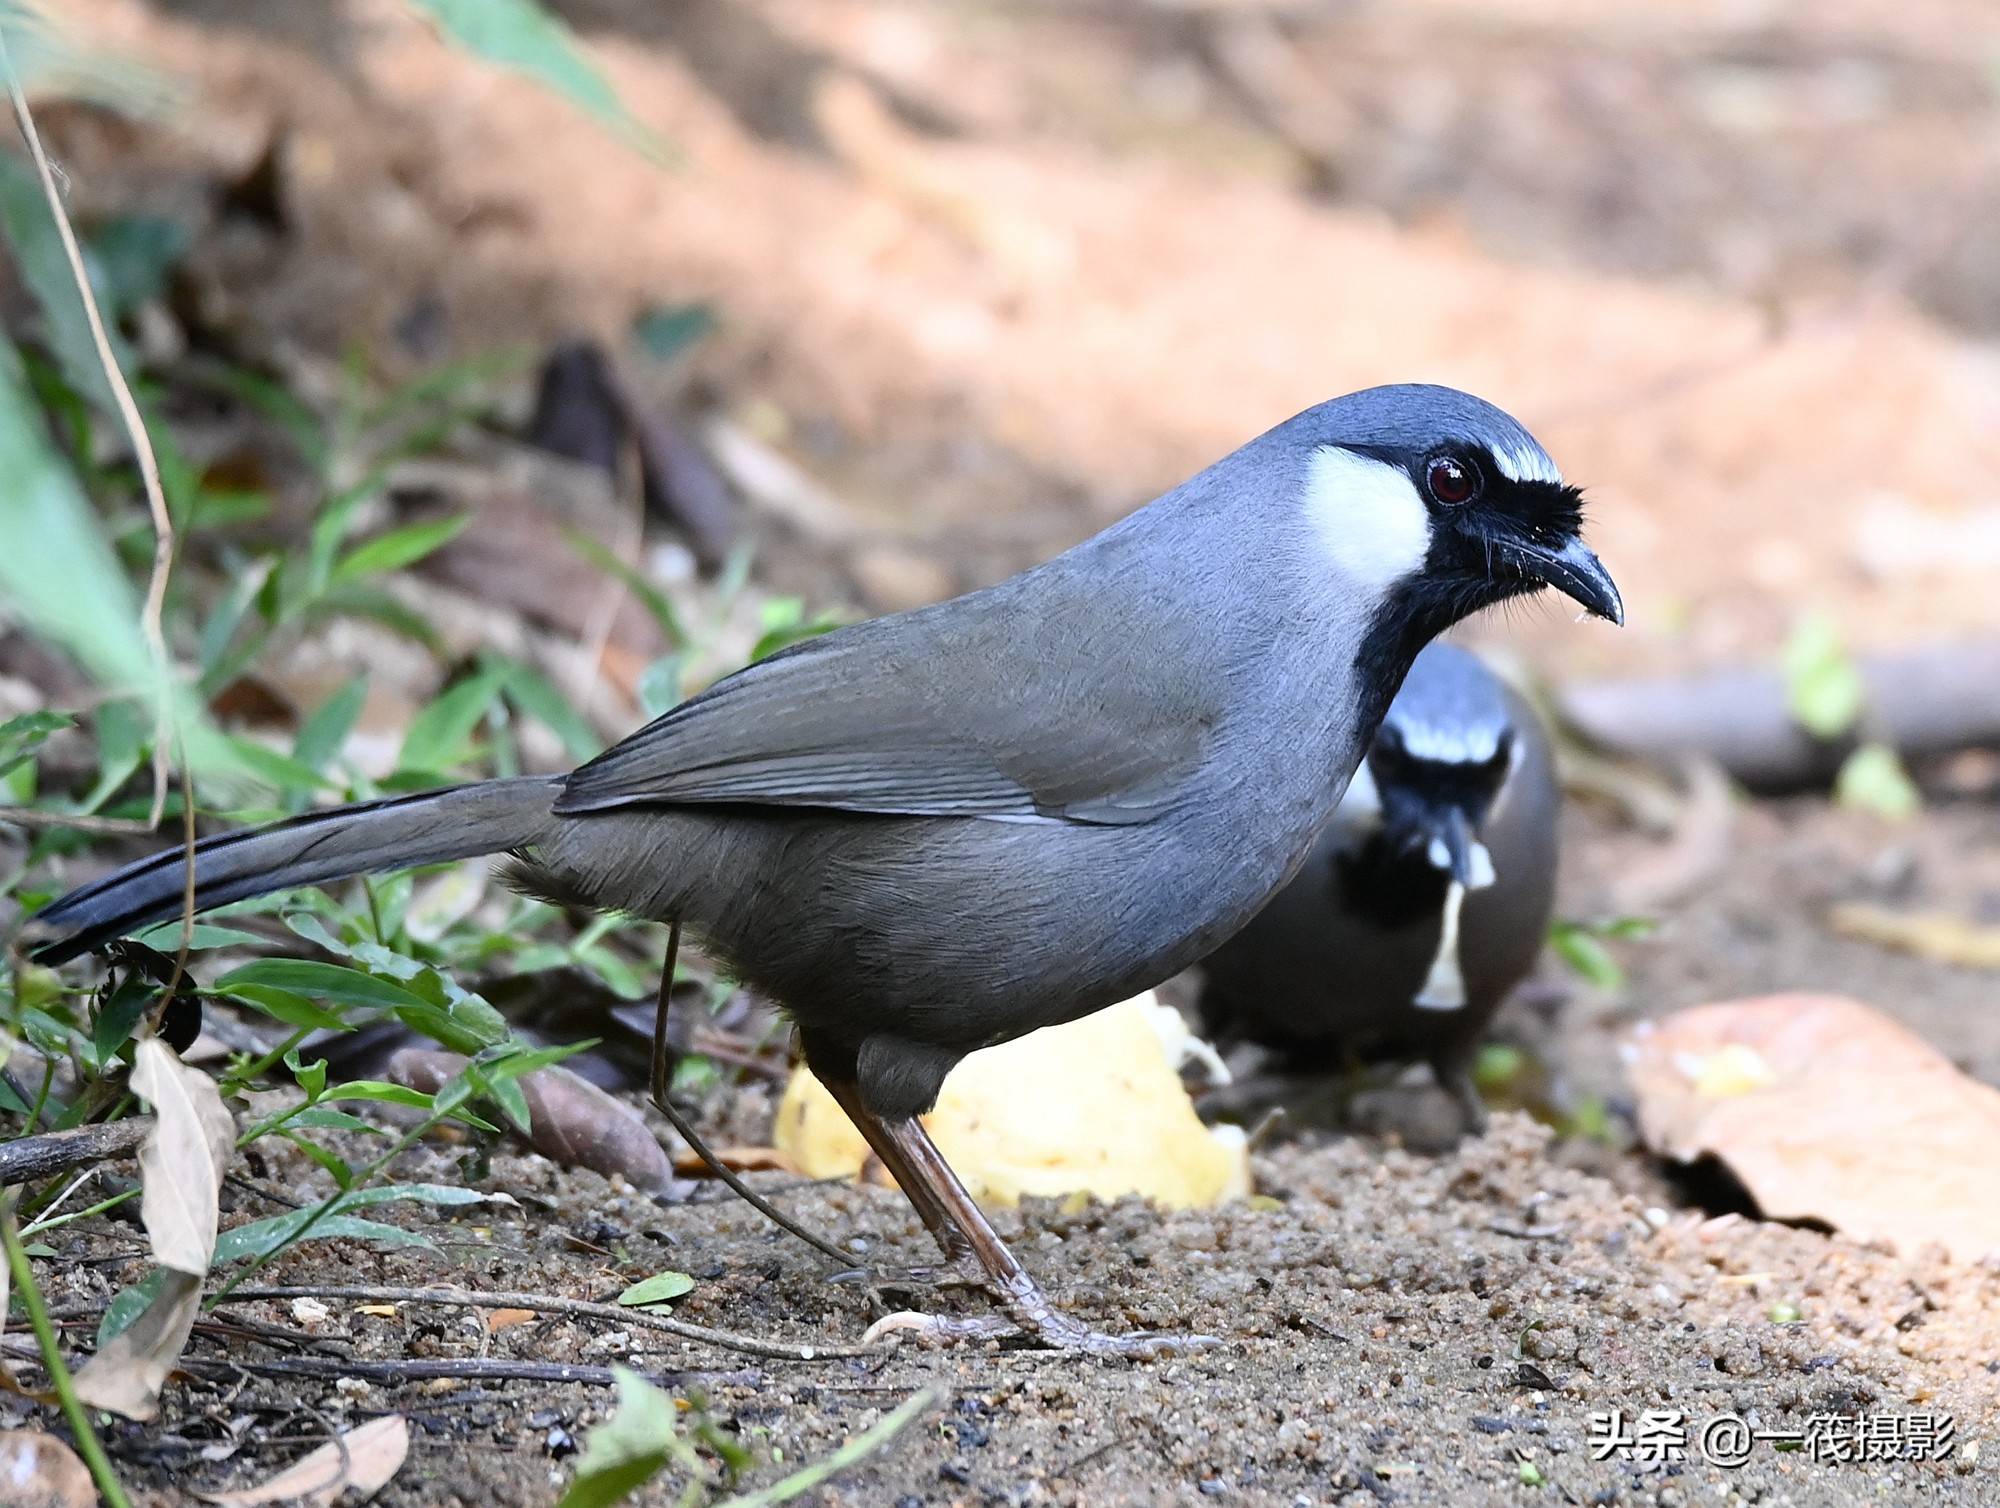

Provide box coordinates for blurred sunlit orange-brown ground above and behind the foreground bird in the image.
[70,0,2000,666]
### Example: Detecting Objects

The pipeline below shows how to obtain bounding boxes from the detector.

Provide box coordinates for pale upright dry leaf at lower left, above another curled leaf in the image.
[132,1036,236,1276]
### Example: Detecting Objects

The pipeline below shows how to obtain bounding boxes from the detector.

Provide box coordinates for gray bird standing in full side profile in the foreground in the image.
[31,386,1624,1354]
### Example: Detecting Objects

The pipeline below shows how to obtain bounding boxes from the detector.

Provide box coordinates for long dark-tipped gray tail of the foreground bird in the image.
[34,776,562,964]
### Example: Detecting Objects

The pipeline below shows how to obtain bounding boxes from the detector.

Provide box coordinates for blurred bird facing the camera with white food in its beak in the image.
[1200,644,1560,1130]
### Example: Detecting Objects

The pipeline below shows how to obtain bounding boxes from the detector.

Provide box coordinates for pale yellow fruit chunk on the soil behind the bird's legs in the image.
[772,992,1250,1208]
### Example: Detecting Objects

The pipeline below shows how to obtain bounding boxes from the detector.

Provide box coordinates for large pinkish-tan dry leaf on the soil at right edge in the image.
[1628,994,2000,1262]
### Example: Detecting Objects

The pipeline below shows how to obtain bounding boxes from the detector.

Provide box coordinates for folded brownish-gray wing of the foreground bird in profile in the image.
[556,568,1224,822]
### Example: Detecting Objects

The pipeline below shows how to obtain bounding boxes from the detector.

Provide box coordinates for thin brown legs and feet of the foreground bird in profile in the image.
[816,1084,1216,1356]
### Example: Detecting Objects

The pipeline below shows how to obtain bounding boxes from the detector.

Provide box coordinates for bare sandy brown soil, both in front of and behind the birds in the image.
[23,0,2000,1508]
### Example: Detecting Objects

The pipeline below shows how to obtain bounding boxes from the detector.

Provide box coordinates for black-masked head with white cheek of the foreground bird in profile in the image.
[1286,384,1624,636]
